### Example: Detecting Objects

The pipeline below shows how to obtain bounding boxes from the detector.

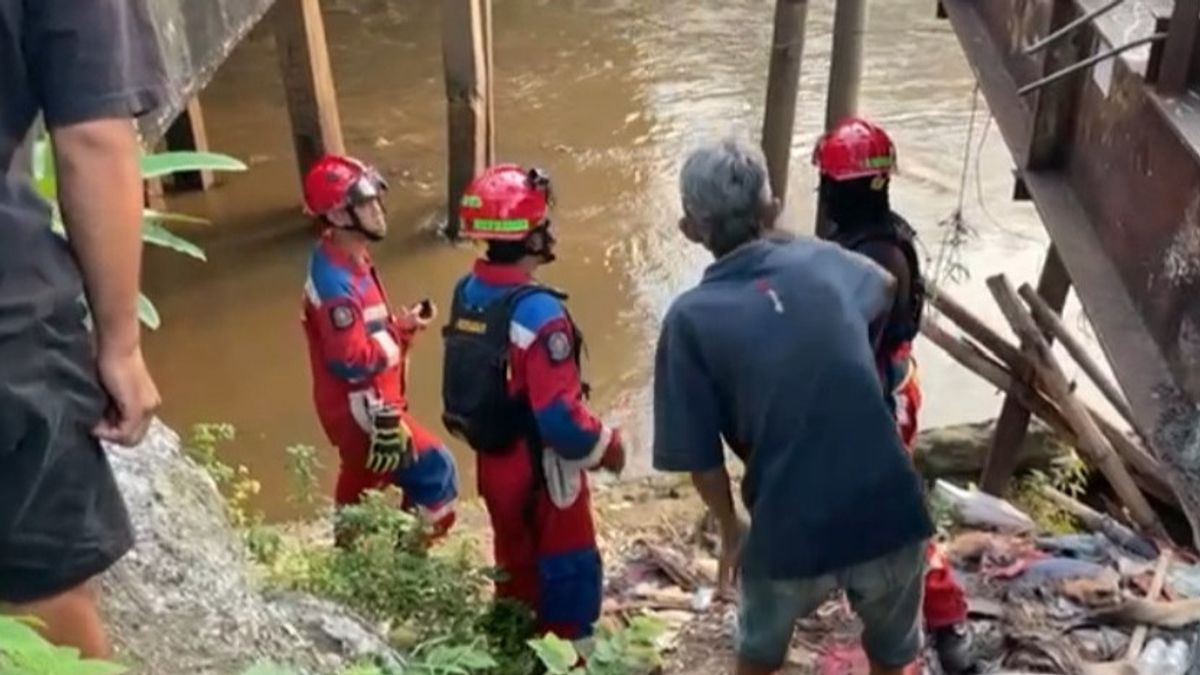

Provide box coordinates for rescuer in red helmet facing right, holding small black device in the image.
[304,156,457,543]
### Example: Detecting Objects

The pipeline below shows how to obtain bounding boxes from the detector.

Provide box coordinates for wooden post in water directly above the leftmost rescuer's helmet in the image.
[271,0,346,179]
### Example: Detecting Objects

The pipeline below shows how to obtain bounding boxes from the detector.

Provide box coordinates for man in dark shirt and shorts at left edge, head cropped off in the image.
[0,0,162,657]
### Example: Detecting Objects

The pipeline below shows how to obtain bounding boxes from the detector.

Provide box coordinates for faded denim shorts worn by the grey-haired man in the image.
[738,539,925,669]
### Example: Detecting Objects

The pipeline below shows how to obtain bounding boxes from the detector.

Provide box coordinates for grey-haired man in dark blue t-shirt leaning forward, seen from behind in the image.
[654,142,932,675]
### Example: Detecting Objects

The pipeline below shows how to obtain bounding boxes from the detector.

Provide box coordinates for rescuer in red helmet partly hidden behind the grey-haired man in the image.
[812,118,972,673]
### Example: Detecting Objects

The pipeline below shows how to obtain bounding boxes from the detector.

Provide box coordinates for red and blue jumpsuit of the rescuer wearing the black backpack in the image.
[462,261,619,639]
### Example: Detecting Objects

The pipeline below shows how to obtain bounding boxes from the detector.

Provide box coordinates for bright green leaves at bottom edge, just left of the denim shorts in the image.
[529,616,666,675]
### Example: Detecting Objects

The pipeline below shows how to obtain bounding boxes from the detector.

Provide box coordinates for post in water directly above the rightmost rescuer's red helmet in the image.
[814,0,866,237]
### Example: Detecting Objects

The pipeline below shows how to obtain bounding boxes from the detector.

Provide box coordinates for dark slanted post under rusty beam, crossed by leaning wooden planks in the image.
[979,245,1070,496]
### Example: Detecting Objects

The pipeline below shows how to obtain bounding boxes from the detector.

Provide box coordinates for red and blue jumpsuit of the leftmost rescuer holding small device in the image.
[304,238,458,536]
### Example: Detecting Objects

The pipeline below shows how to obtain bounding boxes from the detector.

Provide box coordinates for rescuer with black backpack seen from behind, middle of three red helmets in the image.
[443,165,625,639]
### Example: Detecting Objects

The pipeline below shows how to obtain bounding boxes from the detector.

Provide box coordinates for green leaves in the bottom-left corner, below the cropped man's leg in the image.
[0,616,127,675]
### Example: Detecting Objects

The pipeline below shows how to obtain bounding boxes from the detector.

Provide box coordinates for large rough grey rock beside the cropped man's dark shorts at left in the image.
[103,424,390,675]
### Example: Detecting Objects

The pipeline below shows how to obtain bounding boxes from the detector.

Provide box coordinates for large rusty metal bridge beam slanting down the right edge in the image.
[942,0,1200,547]
